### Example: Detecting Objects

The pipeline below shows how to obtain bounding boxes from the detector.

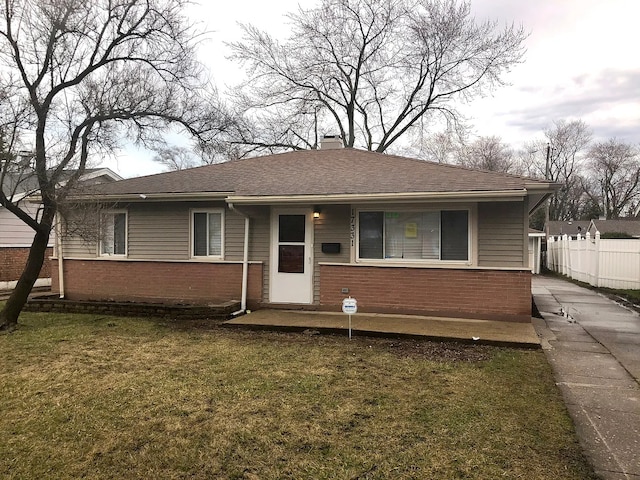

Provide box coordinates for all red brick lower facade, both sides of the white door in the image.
[52,260,531,322]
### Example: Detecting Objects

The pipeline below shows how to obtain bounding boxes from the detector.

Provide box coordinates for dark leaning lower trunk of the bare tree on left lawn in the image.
[0,231,49,331]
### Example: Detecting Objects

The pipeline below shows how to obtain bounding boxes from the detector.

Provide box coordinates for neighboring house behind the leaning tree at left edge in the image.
[0,168,121,290]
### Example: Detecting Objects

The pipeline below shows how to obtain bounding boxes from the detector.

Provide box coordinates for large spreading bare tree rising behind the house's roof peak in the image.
[230,0,526,152]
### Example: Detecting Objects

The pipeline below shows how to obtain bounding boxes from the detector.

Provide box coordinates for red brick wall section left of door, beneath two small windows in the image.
[51,260,262,308]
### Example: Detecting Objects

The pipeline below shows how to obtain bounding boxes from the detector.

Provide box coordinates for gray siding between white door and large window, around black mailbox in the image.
[313,205,351,304]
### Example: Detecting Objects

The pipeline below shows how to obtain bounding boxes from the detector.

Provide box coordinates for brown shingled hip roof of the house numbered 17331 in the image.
[92,148,550,197]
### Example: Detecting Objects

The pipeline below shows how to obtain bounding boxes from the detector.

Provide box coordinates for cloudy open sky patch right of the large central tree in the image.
[468,0,640,144]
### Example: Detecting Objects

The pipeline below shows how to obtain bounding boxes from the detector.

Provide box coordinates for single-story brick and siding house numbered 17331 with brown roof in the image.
[53,145,555,322]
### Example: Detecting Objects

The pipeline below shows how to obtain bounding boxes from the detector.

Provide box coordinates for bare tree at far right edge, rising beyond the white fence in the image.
[587,138,640,218]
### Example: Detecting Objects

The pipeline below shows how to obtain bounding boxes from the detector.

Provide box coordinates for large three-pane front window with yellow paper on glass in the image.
[358,210,469,261]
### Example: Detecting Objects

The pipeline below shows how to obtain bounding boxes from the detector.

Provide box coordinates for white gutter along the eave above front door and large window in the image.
[227,189,528,205]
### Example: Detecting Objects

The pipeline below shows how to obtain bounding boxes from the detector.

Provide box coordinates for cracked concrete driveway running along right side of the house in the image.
[532,275,640,480]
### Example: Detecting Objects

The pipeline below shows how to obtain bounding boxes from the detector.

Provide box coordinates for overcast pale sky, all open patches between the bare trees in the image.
[112,0,640,177]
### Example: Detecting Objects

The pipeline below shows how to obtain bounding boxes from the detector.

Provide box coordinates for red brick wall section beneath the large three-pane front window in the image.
[320,265,531,322]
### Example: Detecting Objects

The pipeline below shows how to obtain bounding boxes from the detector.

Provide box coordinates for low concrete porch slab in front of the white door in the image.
[224,310,540,348]
